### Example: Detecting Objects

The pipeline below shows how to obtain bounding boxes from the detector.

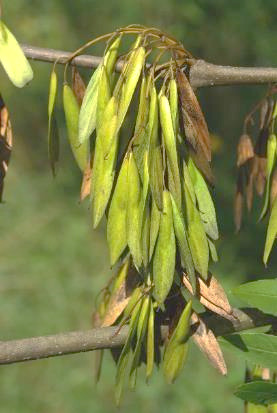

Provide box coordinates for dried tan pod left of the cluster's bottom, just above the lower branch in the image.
[101,267,139,327]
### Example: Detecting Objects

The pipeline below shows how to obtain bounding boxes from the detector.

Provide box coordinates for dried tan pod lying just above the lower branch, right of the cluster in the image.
[183,273,234,320]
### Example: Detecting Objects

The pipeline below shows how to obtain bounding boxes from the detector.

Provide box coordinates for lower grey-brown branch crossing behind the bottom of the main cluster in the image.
[0,309,277,364]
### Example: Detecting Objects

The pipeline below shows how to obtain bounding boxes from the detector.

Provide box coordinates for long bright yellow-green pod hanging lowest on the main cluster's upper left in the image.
[92,97,118,228]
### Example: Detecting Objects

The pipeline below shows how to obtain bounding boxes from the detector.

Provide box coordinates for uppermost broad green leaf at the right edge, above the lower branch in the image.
[232,279,277,315]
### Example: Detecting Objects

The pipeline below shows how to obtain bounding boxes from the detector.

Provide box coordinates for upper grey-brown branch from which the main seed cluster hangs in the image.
[22,45,277,88]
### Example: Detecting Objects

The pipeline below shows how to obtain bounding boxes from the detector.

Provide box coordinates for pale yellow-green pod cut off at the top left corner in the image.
[0,21,34,87]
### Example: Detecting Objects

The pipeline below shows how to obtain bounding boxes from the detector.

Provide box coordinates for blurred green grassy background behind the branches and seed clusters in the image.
[0,0,277,413]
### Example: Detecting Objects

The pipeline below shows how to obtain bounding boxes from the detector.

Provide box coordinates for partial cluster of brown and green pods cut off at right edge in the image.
[234,86,277,264]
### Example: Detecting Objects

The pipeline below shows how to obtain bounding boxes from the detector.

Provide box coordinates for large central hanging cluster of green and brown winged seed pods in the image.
[48,26,233,401]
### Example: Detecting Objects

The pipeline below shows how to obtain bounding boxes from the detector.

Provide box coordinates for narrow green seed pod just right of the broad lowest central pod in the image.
[171,196,196,291]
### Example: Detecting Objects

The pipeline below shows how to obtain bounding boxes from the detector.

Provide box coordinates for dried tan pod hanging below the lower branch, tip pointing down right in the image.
[191,313,227,376]
